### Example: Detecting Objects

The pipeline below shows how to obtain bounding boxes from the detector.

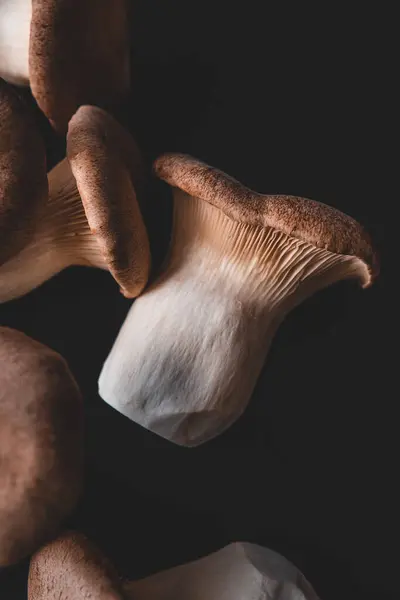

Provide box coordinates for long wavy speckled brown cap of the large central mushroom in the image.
[154,153,379,287]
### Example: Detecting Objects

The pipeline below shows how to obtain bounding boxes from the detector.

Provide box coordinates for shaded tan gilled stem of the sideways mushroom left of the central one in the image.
[0,159,107,303]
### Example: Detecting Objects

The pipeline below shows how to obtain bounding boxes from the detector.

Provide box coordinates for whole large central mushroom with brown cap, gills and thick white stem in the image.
[99,154,378,446]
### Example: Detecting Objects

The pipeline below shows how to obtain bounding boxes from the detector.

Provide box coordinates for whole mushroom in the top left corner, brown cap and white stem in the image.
[0,0,130,133]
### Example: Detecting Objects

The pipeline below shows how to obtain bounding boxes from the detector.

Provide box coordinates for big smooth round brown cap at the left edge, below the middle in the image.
[0,327,83,567]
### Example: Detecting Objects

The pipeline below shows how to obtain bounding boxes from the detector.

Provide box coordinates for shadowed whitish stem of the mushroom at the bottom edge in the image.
[125,543,318,600]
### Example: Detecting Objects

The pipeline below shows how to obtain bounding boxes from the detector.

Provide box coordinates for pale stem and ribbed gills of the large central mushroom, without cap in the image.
[99,189,366,446]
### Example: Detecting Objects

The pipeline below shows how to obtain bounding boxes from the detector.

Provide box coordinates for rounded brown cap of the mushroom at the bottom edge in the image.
[28,532,124,600]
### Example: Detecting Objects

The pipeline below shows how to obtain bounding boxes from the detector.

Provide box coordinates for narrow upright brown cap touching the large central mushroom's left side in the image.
[67,106,150,298]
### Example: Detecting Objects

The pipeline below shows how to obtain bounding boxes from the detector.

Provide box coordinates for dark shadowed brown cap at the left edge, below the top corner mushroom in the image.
[0,78,48,265]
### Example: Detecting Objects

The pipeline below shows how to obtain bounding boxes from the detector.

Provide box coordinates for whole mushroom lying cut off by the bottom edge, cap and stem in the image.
[28,532,318,600]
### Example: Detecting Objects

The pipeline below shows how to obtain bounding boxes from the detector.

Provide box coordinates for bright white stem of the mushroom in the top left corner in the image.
[0,0,32,85]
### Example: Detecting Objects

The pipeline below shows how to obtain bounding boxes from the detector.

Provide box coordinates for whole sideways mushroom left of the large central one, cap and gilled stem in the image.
[0,106,150,302]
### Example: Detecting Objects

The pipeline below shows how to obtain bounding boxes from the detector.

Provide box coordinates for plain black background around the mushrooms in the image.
[0,0,390,600]
